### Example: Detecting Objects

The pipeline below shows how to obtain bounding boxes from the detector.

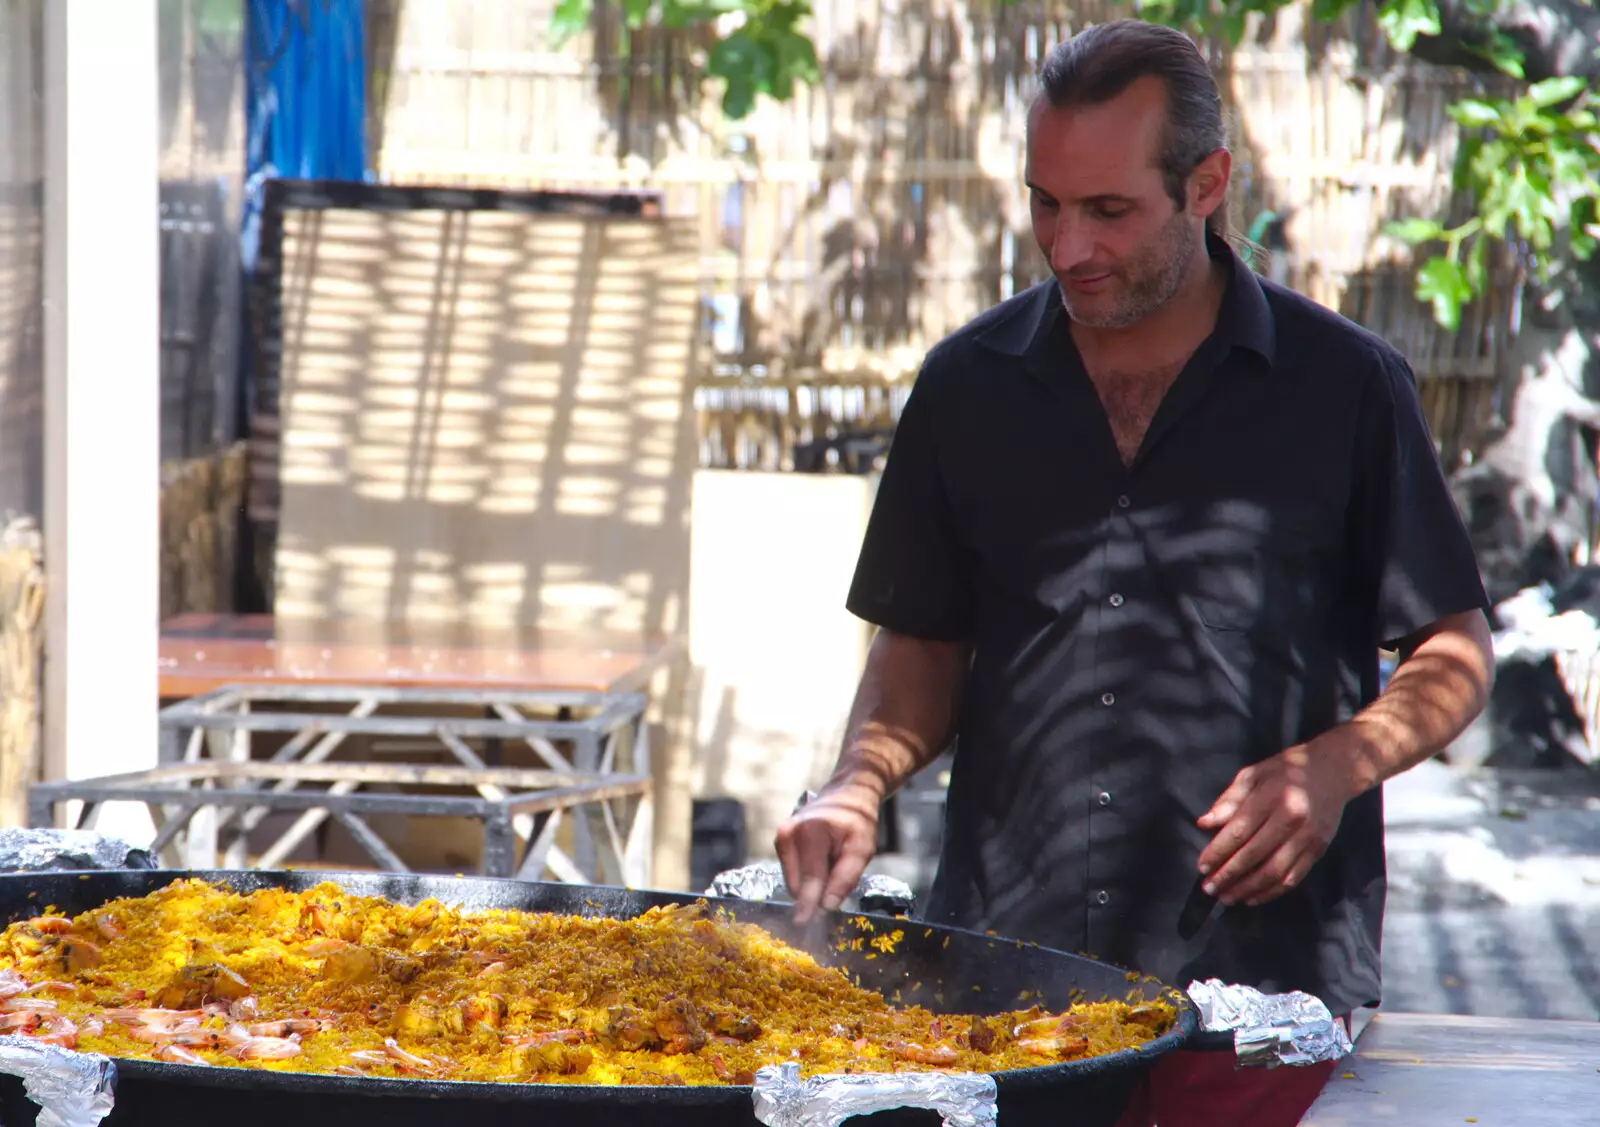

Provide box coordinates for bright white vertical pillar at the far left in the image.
[45,0,160,842]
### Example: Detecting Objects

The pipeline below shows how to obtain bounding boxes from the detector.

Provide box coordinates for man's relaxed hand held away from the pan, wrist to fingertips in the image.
[1195,733,1355,908]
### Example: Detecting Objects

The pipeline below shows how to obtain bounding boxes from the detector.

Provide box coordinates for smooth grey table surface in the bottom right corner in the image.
[1301,1013,1600,1127]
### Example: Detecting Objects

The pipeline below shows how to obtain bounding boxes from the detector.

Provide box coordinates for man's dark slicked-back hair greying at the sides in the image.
[1038,19,1227,237]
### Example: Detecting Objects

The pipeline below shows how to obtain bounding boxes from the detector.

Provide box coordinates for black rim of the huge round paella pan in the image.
[0,869,1198,1108]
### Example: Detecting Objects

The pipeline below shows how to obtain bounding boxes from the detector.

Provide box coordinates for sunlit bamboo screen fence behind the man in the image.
[371,0,1506,464]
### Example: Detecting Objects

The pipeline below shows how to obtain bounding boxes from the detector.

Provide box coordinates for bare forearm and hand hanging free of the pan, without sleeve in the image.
[1198,610,1494,906]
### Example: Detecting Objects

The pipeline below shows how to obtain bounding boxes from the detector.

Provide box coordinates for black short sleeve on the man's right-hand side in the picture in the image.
[1352,355,1488,648]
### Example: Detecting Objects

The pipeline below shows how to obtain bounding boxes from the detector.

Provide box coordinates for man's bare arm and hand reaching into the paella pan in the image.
[778,629,971,924]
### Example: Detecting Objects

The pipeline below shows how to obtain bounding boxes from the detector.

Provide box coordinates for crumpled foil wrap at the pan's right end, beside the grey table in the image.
[1189,978,1352,1068]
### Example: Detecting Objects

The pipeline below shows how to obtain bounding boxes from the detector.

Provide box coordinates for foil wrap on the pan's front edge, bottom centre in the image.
[755,1061,998,1127]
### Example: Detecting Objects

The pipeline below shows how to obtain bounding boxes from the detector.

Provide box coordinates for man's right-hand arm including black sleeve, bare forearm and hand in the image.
[1197,354,1494,904]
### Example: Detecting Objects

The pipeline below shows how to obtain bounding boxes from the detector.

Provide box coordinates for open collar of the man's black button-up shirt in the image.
[976,231,1277,371]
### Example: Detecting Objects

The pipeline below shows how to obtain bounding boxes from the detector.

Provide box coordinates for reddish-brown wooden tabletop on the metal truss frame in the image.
[160,615,680,700]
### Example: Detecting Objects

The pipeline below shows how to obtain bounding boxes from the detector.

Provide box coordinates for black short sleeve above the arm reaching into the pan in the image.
[845,370,973,642]
